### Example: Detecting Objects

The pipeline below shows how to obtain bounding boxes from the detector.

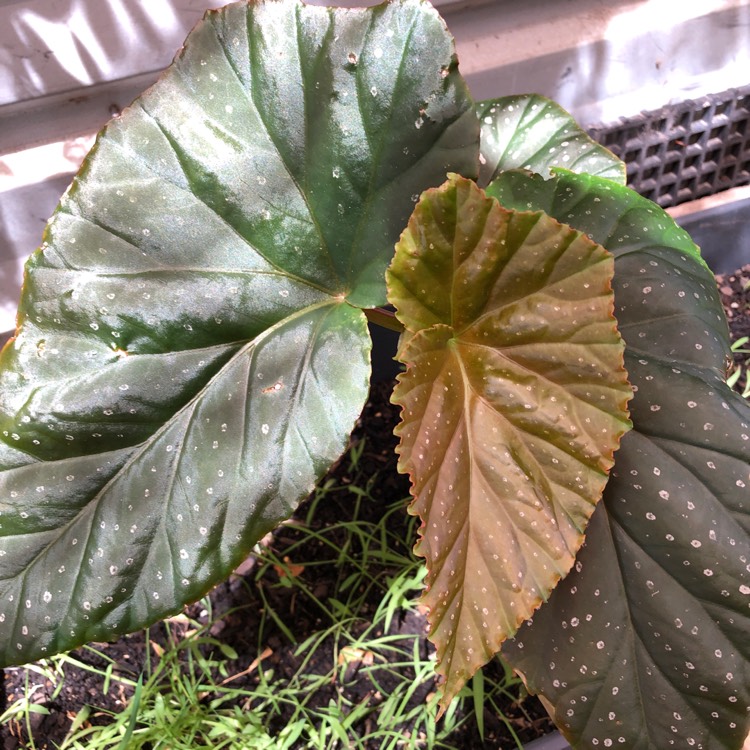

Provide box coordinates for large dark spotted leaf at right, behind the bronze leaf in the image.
[489,173,750,750]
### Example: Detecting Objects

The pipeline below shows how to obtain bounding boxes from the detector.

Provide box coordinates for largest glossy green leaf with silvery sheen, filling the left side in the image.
[0,0,478,664]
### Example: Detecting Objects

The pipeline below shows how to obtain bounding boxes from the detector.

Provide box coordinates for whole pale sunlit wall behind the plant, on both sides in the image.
[0,0,750,332]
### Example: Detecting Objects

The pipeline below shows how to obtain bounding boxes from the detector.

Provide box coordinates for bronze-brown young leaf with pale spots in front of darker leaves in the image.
[387,177,630,706]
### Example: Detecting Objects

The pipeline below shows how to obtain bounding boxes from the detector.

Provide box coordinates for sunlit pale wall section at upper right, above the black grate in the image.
[468,0,750,126]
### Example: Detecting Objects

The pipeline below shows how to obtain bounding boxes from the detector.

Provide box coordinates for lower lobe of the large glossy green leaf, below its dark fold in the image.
[0,304,367,663]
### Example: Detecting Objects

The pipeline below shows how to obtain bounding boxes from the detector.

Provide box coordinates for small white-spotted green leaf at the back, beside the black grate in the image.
[475,94,626,187]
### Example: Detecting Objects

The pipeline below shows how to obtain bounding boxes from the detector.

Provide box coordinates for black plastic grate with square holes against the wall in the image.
[588,85,750,208]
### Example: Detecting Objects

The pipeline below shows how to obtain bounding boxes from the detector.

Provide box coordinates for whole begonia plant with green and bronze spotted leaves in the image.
[0,0,750,750]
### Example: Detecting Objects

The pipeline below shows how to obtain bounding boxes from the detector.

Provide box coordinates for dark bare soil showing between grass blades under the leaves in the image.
[0,272,750,750]
